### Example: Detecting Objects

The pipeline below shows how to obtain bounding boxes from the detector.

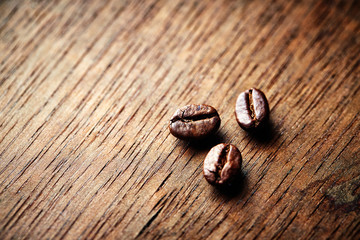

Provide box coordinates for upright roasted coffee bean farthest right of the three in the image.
[235,88,269,130]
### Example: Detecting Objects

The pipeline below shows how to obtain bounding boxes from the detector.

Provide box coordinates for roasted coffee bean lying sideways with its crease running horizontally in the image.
[169,104,220,140]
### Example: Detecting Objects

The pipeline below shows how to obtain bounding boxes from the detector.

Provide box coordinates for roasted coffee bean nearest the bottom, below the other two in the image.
[204,143,242,187]
